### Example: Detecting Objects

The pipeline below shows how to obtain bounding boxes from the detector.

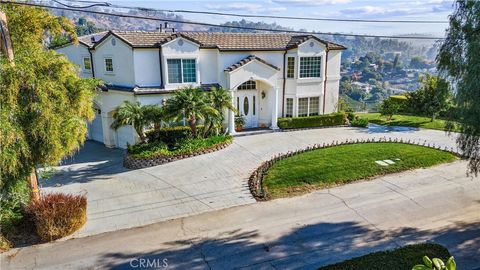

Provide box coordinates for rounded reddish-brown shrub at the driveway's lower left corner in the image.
[27,193,87,241]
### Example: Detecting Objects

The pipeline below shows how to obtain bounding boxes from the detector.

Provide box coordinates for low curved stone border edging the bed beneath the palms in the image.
[123,139,233,169]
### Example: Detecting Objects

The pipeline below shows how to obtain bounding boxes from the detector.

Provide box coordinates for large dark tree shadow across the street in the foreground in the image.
[98,222,480,269]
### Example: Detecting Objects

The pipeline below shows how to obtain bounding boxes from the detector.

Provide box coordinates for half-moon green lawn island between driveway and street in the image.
[263,143,457,199]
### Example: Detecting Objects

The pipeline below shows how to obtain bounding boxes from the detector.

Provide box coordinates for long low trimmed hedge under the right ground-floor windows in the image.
[278,113,345,129]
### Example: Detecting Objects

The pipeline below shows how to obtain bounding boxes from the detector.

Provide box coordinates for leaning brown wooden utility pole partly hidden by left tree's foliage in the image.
[0,11,40,201]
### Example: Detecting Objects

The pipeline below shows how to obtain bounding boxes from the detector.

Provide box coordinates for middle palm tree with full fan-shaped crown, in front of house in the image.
[165,87,219,138]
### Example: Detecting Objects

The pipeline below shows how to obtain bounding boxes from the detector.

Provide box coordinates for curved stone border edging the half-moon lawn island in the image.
[248,137,463,201]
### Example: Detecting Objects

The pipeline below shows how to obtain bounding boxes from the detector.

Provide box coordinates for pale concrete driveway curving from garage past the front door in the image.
[42,126,455,237]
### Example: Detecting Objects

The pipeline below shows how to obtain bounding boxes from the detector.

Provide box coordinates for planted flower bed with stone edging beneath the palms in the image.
[123,136,233,169]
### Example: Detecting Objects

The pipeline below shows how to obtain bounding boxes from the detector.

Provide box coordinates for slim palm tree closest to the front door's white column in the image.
[204,87,237,135]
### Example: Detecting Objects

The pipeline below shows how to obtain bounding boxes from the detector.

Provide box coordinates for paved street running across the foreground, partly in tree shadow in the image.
[0,159,480,270]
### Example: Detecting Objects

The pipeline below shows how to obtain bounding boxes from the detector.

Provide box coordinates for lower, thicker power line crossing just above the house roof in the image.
[0,0,444,40]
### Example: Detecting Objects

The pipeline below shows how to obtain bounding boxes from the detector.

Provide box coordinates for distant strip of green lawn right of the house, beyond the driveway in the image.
[357,113,458,131]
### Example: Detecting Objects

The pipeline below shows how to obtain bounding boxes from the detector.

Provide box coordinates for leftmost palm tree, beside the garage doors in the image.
[111,101,148,142]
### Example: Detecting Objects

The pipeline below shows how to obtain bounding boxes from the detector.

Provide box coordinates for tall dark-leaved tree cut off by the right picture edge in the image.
[437,0,480,175]
